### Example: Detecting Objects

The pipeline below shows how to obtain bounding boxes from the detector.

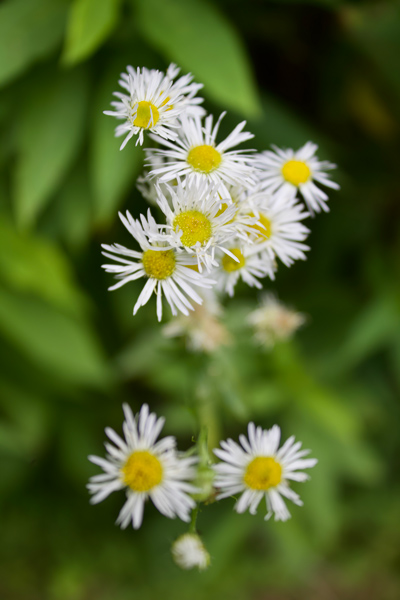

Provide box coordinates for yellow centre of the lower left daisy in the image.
[121,450,163,492]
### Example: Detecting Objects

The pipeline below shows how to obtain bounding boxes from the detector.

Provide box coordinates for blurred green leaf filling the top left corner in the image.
[0,0,67,85]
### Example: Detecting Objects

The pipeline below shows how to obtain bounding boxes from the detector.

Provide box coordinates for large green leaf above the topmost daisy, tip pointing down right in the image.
[135,0,260,116]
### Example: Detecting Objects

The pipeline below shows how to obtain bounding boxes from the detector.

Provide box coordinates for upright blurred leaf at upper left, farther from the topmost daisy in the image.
[15,71,88,227]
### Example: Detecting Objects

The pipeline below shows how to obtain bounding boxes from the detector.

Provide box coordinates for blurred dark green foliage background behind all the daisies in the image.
[0,0,400,600]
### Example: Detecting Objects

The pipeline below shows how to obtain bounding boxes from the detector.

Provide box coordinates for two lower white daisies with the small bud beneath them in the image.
[88,404,317,568]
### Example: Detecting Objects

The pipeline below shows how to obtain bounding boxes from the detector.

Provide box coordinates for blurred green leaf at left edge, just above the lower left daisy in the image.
[0,288,111,387]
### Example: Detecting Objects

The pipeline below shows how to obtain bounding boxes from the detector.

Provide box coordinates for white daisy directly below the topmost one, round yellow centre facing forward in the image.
[147,113,254,196]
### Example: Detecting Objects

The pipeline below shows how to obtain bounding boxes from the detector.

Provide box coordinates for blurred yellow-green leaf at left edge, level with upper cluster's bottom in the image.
[0,218,86,314]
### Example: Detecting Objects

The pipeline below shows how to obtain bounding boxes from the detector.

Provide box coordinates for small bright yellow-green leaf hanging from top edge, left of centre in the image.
[62,0,120,65]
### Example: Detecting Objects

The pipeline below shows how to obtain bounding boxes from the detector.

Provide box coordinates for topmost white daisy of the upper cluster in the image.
[104,65,202,150]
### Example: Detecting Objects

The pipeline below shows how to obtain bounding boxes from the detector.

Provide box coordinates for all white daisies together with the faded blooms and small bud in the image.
[93,64,339,570]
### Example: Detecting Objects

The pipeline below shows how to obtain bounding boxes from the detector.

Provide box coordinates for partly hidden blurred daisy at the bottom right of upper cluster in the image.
[213,244,276,297]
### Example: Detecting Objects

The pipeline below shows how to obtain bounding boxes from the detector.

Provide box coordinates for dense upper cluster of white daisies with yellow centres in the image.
[103,65,338,320]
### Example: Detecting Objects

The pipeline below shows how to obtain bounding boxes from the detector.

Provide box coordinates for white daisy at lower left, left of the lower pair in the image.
[87,404,197,529]
